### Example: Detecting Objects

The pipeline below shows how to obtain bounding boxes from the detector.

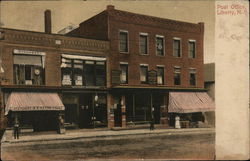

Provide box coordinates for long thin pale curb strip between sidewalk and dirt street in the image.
[1,129,215,144]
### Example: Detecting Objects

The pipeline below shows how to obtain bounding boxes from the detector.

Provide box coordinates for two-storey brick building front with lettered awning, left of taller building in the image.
[0,28,109,131]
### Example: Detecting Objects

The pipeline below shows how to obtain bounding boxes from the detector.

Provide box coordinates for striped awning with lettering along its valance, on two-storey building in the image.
[5,92,65,114]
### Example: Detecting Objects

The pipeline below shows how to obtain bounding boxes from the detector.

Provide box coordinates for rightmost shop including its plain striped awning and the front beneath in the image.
[168,92,215,127]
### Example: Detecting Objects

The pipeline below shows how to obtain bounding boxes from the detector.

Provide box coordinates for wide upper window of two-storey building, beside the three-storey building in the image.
[61,58,106,86]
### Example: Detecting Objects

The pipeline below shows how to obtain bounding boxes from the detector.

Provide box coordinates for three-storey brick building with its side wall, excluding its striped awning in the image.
[67,5,214,127]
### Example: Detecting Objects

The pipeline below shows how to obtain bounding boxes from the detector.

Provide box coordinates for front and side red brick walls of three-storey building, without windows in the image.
[71,6,204,88]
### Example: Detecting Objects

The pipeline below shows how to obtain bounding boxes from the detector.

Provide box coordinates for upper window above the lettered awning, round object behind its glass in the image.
[13,55,44,85]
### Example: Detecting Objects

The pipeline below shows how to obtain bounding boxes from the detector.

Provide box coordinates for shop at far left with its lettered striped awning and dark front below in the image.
[5,92,65,131]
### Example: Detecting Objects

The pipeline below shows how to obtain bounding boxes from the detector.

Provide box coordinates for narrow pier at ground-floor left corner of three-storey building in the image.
[107,93,115,128]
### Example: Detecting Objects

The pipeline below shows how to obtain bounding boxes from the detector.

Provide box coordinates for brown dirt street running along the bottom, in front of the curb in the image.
[2,133,215,161]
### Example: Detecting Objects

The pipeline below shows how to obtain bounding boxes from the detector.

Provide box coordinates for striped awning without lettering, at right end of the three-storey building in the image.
[168,92,215,113]
